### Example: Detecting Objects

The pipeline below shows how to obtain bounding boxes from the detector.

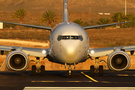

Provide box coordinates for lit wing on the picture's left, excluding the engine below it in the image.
[0,46,50,57]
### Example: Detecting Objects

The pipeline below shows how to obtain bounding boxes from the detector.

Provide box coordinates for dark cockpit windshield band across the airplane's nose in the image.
[57,35,83,41]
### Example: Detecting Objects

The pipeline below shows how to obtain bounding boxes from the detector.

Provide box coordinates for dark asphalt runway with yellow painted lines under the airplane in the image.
[0,70,135,90]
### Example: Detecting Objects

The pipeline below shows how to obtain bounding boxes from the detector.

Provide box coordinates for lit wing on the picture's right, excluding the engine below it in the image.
[89,45,135,57]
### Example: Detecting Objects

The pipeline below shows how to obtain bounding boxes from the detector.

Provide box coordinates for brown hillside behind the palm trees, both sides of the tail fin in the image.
[0,0,135,27]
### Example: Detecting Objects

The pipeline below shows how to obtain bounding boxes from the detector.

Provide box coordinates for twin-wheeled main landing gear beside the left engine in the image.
[32,58,45,76]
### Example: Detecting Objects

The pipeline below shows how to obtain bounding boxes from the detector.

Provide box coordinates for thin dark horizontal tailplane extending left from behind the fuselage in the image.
[0,21,52,31]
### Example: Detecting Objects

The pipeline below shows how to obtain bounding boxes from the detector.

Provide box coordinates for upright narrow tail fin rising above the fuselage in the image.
[63,0,69,22]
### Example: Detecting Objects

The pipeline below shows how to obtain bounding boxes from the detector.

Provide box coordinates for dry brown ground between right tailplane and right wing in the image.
[87,28,135,47]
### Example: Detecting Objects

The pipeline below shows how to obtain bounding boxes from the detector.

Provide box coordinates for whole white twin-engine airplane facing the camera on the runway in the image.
[0,0,135,77]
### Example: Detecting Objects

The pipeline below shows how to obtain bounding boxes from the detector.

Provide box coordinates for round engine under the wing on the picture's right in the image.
[107,51,131,71]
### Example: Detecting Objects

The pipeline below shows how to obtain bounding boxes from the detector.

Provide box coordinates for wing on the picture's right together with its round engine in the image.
[89,45,135,71]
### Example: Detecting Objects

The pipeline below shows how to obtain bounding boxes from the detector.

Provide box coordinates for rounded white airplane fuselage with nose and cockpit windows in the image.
[50,22,89,64]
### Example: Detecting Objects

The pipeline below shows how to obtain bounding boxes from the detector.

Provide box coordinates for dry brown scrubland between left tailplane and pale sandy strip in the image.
[0,29,50,42]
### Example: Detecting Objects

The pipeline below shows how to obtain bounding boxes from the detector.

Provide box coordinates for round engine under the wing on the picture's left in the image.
[6,51,29,71]
